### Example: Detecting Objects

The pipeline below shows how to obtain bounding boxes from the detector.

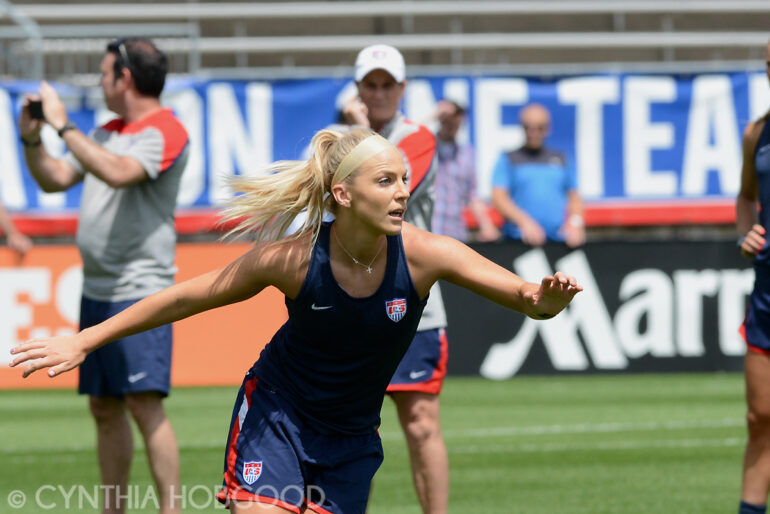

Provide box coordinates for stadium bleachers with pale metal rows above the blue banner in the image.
[0,0,770,80]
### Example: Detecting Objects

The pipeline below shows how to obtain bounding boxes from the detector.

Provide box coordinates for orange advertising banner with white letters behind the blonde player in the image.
[0,243,287,389]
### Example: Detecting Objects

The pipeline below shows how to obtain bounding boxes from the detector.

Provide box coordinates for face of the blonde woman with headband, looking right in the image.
[340,147,409,235]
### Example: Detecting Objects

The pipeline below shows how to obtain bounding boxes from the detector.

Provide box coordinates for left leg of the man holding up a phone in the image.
[89,396,134,514]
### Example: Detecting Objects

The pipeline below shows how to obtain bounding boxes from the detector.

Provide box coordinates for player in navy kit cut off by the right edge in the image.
[735,38,770,514]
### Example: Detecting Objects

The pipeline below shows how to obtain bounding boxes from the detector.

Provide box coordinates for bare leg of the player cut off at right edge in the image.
[740,351,770,513]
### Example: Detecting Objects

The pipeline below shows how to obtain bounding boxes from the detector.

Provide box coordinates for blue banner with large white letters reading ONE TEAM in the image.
[0,72,770,213]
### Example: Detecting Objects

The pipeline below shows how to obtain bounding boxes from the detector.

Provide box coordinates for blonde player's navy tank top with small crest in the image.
[253,223,425,434]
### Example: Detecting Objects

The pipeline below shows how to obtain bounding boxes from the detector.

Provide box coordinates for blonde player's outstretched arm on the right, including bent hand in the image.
[404,226,583,319]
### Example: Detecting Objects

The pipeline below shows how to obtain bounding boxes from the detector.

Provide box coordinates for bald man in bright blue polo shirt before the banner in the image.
[492,104,585,248]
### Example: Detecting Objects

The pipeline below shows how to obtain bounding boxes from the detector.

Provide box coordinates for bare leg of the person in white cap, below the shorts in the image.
[392,391,449,514]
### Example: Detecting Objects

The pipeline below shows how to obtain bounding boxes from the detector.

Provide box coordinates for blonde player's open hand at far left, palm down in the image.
[11,335,86,378]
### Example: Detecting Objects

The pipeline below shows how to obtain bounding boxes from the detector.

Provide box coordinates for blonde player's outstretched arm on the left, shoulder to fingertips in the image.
[11,243,294,377]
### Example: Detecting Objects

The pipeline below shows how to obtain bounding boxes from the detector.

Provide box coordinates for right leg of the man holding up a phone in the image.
[126,392,182,514]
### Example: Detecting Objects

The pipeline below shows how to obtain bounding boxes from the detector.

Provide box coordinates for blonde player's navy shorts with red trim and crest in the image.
[217,372,383,514]
